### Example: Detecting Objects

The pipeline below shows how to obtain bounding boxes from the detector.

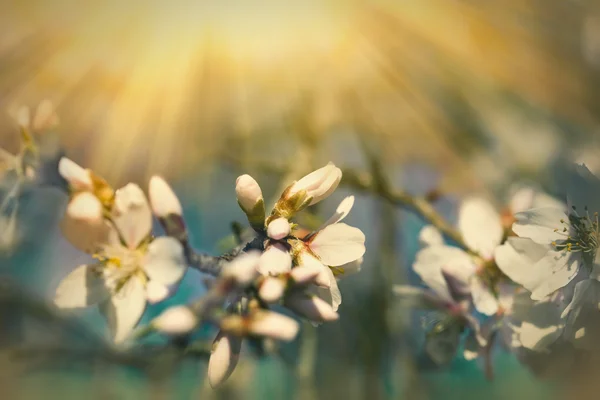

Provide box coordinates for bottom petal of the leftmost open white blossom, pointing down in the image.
[100,277,146,343]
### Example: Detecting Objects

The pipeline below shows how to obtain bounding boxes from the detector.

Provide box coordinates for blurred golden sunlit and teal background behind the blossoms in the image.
[0,0,600,399]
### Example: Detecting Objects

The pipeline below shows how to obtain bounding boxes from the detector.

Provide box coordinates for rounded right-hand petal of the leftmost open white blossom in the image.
[142,236,187,286]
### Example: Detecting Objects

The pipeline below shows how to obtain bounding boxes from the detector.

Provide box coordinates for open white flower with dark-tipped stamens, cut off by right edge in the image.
[499,165,600,300]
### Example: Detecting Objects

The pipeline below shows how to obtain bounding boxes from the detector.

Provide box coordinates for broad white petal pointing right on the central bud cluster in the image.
[309,223,365,267]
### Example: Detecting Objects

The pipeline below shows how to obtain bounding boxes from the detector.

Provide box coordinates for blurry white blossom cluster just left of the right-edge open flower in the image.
[395,188,561,374]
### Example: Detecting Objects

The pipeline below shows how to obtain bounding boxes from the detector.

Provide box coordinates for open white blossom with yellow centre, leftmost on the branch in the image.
[55,184,186,342]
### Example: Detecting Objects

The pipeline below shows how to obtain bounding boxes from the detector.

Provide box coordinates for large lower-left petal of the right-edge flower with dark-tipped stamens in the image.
[495,238,579,300]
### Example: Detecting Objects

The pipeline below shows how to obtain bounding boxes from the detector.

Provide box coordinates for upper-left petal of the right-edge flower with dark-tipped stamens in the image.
[512,207,569,244]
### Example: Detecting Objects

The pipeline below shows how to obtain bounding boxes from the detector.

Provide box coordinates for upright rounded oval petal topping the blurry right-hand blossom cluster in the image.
[458,198,504,258]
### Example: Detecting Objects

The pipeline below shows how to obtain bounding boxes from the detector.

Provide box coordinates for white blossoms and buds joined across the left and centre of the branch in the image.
[55,158,365,386]
